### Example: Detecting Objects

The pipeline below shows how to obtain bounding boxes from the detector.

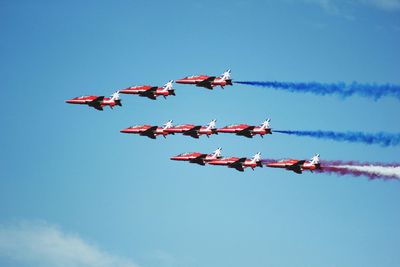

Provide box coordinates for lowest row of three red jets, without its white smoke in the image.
[170,148,321,174]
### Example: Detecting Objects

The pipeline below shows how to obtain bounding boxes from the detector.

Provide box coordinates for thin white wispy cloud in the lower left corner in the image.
[0,222,138,267]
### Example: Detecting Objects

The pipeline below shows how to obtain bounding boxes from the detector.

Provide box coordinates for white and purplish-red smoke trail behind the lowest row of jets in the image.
[318,161,400,180]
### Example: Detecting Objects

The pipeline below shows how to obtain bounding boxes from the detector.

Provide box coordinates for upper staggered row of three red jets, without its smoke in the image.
[65,70,232,111]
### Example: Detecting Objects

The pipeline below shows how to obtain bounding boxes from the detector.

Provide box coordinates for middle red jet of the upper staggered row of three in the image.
[119,80,175,100]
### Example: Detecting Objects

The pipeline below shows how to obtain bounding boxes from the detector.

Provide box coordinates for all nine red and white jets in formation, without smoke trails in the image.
[65,70,321,174]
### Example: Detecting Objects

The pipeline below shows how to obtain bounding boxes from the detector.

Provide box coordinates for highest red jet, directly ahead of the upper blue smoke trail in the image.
[176,70,232,90]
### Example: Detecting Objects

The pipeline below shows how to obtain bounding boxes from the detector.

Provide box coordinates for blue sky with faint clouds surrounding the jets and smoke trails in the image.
[0,0,400,267]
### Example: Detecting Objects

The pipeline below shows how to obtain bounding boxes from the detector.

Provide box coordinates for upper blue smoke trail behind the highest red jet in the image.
[235,81,400,100]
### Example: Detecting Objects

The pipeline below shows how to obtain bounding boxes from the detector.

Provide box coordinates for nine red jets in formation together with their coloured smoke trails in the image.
[66,70,400,179]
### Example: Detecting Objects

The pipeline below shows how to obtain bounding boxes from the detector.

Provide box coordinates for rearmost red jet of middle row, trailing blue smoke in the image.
[217,119,272,138]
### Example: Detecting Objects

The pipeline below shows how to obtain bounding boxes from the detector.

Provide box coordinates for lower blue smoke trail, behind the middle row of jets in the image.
[273,130,400,146]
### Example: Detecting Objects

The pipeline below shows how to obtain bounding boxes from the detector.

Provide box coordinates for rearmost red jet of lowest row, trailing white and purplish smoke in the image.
[265,154,321,174]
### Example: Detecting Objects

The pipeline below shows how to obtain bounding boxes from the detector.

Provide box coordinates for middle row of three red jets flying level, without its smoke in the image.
[120,119,272,139]
